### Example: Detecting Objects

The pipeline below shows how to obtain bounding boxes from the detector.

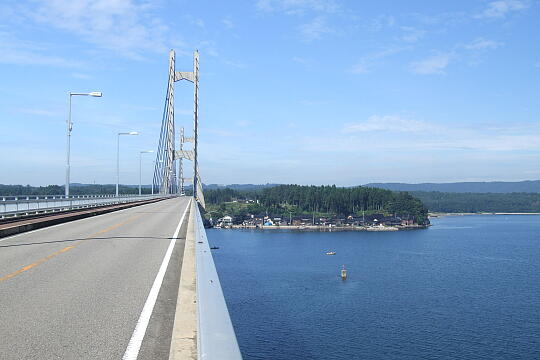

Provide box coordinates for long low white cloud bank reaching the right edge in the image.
[298,119,540,156]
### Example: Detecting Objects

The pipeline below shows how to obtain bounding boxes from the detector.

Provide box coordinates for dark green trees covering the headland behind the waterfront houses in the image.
[204,185,427,224]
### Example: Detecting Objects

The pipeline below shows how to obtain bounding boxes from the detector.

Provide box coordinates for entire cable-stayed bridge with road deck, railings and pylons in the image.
[0,51,241,360]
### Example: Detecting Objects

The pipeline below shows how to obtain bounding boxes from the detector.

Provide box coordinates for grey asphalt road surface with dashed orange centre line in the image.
[0,198,189,359]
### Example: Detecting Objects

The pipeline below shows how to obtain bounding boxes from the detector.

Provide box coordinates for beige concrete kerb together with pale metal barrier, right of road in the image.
[169,201,242,360]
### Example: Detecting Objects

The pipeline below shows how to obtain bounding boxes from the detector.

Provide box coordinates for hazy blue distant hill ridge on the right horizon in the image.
[364,180,540,194]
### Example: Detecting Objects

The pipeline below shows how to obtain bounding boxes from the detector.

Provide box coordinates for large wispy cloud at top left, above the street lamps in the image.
[24,0,167,59]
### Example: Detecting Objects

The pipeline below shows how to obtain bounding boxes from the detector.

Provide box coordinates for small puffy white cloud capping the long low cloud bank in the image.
[343,115,436,133]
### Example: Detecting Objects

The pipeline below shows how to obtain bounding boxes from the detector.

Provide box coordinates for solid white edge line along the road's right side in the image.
[122,199,191,360]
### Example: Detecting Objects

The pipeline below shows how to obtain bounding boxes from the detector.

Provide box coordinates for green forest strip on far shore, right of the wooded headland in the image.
[411,191,540,213]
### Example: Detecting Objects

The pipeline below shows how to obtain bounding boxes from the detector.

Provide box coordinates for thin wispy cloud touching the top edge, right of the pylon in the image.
[256,0,339,15]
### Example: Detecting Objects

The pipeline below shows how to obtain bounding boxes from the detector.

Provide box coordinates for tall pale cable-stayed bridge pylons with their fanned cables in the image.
[153,50,204,207]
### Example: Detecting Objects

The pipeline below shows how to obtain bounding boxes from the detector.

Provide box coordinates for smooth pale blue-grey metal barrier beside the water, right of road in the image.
[192,205,242,360]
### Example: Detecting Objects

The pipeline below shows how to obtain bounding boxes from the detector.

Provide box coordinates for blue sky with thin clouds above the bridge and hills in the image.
[0,0,540,186]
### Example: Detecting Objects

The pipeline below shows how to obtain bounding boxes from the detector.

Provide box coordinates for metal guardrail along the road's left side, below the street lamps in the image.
[0,194,173,219]
